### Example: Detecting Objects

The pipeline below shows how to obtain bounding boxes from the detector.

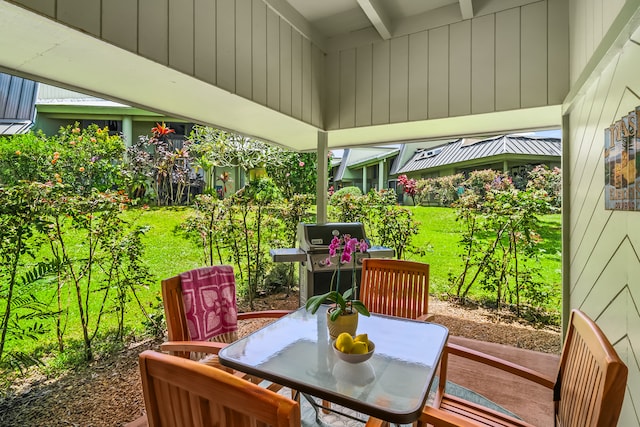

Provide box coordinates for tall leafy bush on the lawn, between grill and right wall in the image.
[451,171,556,315]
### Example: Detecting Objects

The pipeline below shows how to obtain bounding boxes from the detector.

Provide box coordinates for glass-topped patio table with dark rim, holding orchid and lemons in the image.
[218,306,449,423]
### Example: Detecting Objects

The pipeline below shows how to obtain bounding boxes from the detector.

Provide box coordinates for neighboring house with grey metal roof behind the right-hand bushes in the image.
[393,135,562,179]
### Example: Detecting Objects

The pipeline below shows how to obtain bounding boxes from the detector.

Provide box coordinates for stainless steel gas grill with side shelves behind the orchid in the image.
[271,222,395,305]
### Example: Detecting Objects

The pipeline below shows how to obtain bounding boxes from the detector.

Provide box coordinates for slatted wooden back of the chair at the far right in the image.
[556,310,627,427]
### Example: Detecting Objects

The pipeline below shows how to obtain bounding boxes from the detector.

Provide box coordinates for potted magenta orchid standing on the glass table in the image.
[305,230,370,338]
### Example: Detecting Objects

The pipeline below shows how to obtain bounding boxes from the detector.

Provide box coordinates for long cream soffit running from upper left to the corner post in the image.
[0,1,318,150]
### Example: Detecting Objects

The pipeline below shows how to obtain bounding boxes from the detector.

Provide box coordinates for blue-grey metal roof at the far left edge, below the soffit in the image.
[0,73,38,135]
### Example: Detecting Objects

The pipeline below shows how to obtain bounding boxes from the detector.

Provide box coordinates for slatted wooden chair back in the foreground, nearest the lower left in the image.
[140,350,300,427]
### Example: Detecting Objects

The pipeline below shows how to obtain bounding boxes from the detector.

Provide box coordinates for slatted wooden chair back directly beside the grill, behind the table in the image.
[360,258,429,319]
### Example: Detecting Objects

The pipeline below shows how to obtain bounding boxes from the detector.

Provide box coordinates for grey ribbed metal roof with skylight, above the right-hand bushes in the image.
[396,135,562,174]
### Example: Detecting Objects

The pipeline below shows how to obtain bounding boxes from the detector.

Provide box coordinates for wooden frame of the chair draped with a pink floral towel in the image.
[161,265,290,364]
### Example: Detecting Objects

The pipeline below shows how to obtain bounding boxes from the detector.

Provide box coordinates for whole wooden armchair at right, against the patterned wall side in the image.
[367,310,627,427]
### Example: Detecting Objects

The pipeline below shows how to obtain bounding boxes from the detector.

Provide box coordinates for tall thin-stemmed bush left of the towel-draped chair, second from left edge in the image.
[45,192,149,361]
